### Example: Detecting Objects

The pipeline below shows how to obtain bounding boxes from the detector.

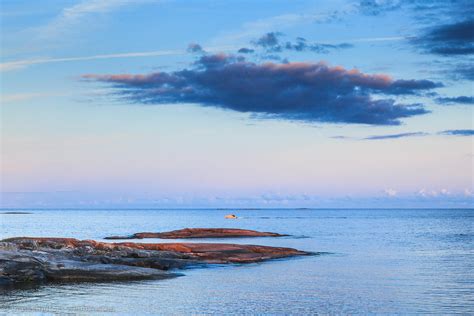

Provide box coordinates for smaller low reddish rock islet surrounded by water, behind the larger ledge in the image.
[105,228,288,239]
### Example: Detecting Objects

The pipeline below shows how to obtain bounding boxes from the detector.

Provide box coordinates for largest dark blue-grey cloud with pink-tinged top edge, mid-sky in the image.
[83,54,439,125]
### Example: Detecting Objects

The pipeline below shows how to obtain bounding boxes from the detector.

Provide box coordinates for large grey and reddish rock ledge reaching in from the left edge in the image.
[0,237,309,288]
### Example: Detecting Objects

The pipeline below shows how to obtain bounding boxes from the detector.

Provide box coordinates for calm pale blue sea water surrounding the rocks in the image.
[0,209,474,315]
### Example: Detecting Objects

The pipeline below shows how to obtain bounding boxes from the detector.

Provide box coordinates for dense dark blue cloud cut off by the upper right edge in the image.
[412,18,474,56]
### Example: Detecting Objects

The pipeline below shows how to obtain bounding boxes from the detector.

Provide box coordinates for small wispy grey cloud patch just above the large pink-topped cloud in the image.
[253,32,353,54]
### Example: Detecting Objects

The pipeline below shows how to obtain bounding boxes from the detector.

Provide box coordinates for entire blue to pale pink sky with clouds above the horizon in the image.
[0,0,474,209]
